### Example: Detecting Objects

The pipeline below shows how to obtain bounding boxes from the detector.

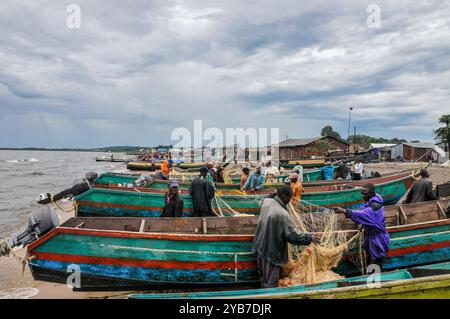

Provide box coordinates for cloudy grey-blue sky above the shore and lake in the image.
[0,0,450,147]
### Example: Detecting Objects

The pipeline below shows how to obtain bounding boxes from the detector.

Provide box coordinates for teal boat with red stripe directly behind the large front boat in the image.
[75,175,414,217]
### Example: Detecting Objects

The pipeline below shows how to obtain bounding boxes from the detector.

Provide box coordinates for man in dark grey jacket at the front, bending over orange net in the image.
[252,185,319,288]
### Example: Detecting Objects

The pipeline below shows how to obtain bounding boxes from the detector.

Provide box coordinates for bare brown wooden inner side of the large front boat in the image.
[61,199,450,235]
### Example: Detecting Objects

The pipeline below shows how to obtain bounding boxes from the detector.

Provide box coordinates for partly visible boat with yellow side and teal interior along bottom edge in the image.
[128,262,450,299]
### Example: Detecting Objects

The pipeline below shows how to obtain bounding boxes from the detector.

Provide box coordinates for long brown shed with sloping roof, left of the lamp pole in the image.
[278,136,350,161]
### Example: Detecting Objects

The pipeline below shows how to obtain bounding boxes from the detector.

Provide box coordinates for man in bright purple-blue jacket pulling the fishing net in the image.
[335,183,389,270]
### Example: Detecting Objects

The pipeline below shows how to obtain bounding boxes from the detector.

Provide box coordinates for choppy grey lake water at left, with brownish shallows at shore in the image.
[0,151,130,299]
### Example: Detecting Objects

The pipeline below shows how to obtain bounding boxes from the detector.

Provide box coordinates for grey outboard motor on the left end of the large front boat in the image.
[0,205,59,256]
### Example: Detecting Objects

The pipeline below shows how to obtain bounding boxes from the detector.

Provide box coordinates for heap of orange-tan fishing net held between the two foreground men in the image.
[278,202,362,287]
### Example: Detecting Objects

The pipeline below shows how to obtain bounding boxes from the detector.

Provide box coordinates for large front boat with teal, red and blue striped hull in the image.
[28,200,450,289]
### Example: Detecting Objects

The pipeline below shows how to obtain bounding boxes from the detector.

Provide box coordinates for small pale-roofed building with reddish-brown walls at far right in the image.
[391,142,445,162]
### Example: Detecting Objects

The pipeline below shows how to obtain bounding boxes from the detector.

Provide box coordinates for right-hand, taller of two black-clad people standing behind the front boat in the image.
[189,167,214,217]
